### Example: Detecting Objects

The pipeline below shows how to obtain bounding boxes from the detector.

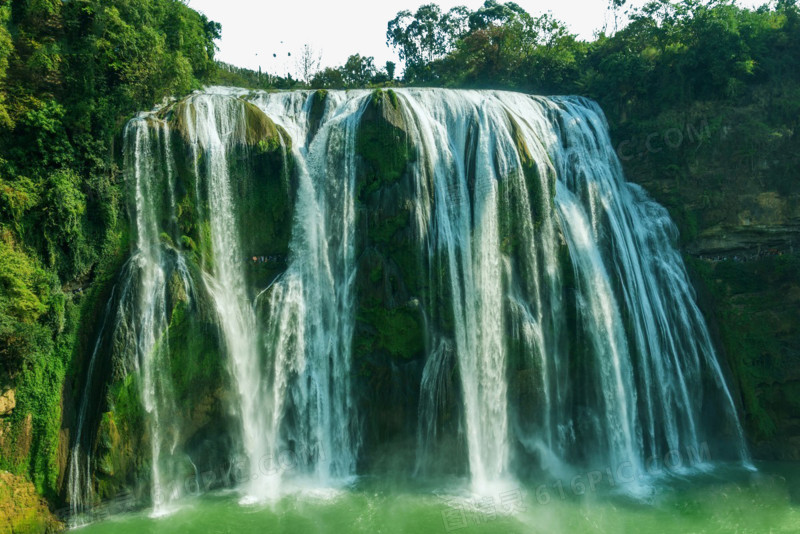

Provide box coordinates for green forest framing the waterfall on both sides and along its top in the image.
[0,0,800,528]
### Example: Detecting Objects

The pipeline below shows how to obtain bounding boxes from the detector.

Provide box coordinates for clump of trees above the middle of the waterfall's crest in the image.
[387,0,586,92]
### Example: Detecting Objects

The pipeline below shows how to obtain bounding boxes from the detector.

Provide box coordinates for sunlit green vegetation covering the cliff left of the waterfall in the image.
[0,0,220,510]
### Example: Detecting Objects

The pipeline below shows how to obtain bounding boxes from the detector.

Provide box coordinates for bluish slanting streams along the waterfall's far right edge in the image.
[551,98,748,463]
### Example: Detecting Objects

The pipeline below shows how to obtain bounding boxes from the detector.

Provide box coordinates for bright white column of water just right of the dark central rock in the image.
[404,94,508,486]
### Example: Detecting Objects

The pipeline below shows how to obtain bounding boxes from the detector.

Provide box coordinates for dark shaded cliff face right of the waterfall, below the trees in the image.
[616,99,800,460]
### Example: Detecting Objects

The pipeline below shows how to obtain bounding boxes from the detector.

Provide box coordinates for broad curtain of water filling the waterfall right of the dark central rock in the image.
[398,90,746,488]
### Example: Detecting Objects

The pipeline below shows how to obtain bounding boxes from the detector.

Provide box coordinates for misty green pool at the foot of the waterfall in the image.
[75,464,800,534]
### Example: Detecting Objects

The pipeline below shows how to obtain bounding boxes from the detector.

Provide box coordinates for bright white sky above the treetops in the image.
[188,0,766,75]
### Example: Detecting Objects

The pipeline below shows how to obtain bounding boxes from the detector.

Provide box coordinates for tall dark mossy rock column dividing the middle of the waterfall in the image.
[353,91,434,467]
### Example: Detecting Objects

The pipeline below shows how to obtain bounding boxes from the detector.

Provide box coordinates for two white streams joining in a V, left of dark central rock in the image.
[173,89,360,501]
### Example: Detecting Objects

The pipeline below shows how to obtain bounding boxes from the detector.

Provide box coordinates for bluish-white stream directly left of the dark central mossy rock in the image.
[254,89,364,483]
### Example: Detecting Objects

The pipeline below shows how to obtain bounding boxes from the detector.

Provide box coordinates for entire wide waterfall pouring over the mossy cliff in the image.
[69,88,748,524]
